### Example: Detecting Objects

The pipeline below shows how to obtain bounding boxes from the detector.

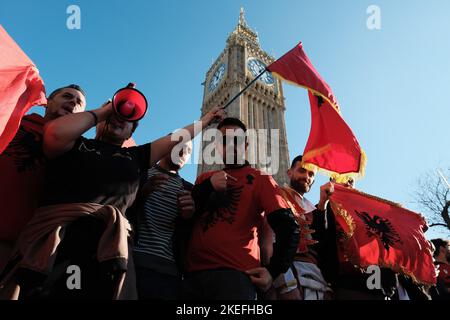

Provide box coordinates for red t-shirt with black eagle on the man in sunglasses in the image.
[188,164,289,272]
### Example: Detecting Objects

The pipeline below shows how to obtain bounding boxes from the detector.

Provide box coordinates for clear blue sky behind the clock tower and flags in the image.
[0,0,450,237]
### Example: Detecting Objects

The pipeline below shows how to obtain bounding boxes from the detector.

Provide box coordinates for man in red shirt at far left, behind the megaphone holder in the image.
[0,85,86,272]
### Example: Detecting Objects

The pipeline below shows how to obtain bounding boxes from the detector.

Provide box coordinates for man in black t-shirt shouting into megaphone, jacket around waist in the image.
[0,85,224,299]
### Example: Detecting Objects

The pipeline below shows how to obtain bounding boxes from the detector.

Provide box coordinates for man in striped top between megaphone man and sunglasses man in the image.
[133,141,194,300]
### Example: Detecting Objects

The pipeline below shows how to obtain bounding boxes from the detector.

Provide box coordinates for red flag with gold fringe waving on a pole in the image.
[267,43,366,178]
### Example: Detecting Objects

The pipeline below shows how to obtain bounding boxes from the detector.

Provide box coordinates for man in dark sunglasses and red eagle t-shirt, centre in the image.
[184,118,299,300]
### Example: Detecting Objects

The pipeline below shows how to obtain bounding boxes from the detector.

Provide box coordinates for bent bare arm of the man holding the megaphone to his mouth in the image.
[43,102,112,159]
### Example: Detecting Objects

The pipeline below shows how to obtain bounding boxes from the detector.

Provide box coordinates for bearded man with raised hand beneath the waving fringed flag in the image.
[267,155,333,300]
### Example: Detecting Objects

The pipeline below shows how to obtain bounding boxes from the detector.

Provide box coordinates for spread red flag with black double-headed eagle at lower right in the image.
[330,184,436,285]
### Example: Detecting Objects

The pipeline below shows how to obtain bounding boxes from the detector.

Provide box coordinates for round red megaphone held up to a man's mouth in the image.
[112,83,147,121]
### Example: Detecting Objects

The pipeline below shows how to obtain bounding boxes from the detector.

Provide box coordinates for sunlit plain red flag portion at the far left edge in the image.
[0,25,47,154]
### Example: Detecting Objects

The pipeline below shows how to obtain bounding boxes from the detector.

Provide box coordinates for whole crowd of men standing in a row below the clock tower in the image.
[0,85,450,300]
